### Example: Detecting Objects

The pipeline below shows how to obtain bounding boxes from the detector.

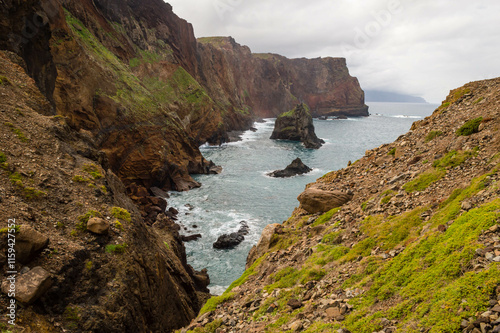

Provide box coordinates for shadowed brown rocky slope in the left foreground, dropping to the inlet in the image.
[0,51,208,332]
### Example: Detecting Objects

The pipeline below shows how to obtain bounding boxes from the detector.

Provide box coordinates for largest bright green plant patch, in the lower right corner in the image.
[344,199,500,333]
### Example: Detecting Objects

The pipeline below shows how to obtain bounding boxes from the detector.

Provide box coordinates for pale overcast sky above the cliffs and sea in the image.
[167,0,500,103]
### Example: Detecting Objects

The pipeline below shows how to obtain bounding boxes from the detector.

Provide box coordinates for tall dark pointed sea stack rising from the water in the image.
[271,103,325,149]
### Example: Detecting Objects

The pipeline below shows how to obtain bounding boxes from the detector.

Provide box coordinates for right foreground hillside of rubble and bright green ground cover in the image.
[184,79,500,333]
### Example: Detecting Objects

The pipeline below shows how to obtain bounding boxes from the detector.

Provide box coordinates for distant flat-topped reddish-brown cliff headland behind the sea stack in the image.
[198,37,368,117]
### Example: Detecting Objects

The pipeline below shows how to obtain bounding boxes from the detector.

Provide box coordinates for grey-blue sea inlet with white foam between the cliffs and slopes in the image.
[169,103,437,294]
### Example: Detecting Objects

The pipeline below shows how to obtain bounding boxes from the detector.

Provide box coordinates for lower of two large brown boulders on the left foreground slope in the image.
[2,266,52,304]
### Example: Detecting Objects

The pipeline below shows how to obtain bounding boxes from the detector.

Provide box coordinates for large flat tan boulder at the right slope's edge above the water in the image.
[297,187,353,214]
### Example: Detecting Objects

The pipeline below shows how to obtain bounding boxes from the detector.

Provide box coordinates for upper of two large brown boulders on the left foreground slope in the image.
[15,224,49,264]
